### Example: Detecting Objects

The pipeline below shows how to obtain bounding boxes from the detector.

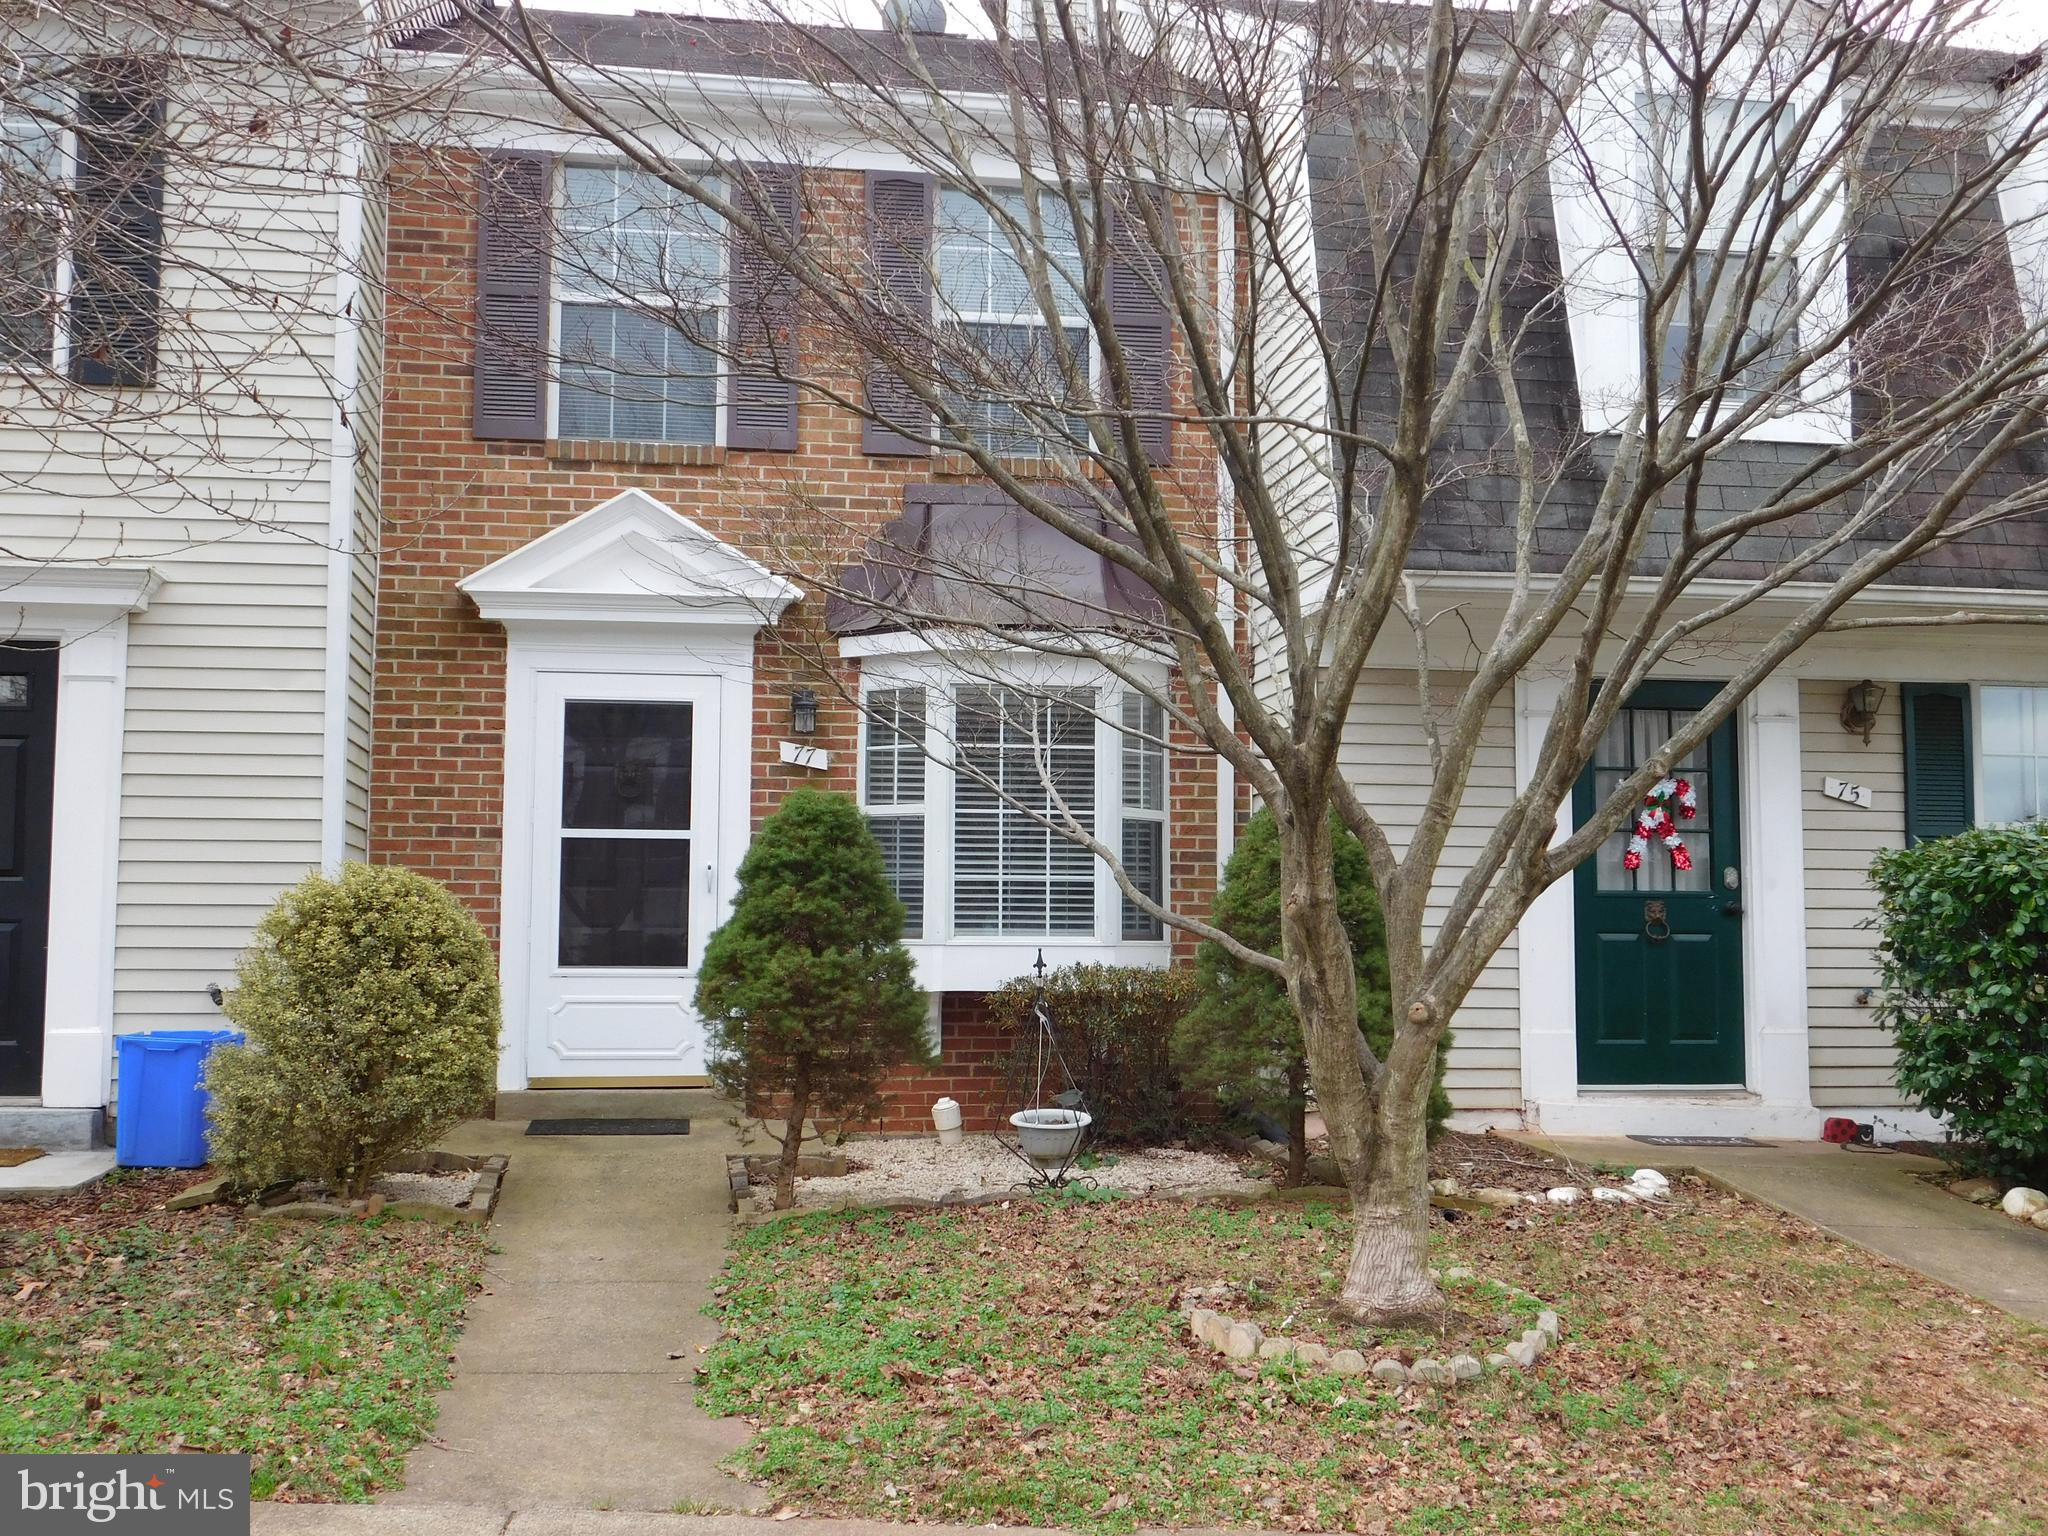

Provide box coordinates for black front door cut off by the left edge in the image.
[0,641,57,1094]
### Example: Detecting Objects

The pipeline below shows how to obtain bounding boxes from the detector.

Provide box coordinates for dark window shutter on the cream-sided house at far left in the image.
[70,59,164,389]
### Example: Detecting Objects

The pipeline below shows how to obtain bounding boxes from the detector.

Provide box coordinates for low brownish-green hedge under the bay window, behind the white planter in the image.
[989,965,1194,1147]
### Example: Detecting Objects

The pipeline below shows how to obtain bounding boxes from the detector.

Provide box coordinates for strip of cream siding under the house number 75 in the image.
[1798,678,1907,1108]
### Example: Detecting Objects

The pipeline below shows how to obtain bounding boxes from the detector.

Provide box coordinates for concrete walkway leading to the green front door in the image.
[1522,1135,2048,1327]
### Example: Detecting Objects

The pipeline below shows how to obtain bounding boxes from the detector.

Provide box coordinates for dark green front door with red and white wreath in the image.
[1573,682,1743,1087]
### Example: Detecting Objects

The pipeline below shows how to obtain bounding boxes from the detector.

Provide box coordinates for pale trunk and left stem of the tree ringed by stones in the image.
[1280,811,1444,1327]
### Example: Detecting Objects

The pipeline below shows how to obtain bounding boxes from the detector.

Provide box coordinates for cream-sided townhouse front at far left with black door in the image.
[0,33,383,1147]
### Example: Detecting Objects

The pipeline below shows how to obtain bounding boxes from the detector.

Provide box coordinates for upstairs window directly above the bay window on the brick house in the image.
[932,188,1090,457]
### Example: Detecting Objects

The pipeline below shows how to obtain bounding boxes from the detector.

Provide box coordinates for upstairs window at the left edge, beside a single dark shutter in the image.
[0,86,68,369]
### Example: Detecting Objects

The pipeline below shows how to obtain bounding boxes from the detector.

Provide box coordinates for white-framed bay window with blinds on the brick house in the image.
[860,678,1167,948]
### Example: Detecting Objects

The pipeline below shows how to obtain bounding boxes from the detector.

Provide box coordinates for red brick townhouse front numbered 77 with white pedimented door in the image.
[371,14,1231,1126]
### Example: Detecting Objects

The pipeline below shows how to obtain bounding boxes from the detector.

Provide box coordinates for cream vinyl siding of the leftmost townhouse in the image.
[0,90,360,1064]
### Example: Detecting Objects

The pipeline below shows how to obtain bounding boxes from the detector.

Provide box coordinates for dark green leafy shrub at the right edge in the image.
[1870,821,2048,1180]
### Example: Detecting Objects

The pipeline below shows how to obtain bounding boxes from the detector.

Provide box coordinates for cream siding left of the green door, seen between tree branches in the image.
[1339,672,1522,1110]
